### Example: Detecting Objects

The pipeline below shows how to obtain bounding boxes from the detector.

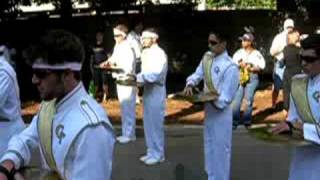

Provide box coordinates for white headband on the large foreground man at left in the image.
[32,59,82,71]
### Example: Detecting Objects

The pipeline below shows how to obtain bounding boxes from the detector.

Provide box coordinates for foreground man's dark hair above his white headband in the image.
[29,30,85,65]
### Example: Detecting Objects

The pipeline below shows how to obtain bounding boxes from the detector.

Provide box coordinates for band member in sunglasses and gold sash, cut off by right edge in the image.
[272,34,320,180]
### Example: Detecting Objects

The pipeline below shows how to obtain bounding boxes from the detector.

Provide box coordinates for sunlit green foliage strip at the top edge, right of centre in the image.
[206,0,277,9]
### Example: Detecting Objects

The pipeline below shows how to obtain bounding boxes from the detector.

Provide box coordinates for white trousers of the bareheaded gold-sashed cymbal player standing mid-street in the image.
[204,103,232,180]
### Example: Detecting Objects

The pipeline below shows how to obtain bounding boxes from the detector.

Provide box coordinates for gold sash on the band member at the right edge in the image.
[291,77,317,124]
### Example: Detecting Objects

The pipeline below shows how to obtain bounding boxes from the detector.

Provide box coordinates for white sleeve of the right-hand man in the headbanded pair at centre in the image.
[137,53,167,83]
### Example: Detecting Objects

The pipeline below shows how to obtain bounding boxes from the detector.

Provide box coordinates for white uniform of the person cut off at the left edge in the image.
[0,56,25,157]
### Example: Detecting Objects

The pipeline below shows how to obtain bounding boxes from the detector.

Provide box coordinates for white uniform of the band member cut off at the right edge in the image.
[287,74,320,180]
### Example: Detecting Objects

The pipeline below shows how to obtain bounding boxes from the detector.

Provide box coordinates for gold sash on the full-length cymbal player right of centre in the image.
[203,53,218,94]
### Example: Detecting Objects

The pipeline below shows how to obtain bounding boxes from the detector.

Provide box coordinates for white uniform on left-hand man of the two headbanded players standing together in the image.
[109,40,136,139]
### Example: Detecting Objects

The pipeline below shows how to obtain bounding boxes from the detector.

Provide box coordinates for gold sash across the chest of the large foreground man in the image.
[38,99,57,171]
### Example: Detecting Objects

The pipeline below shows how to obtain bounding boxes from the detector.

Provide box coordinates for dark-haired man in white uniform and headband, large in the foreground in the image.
[0,30,115,180]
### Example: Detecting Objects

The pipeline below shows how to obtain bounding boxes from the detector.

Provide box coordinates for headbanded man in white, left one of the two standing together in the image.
[100,24,137,144]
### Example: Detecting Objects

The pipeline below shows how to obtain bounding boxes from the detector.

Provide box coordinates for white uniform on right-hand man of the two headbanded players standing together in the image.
[137,44,168,160]
